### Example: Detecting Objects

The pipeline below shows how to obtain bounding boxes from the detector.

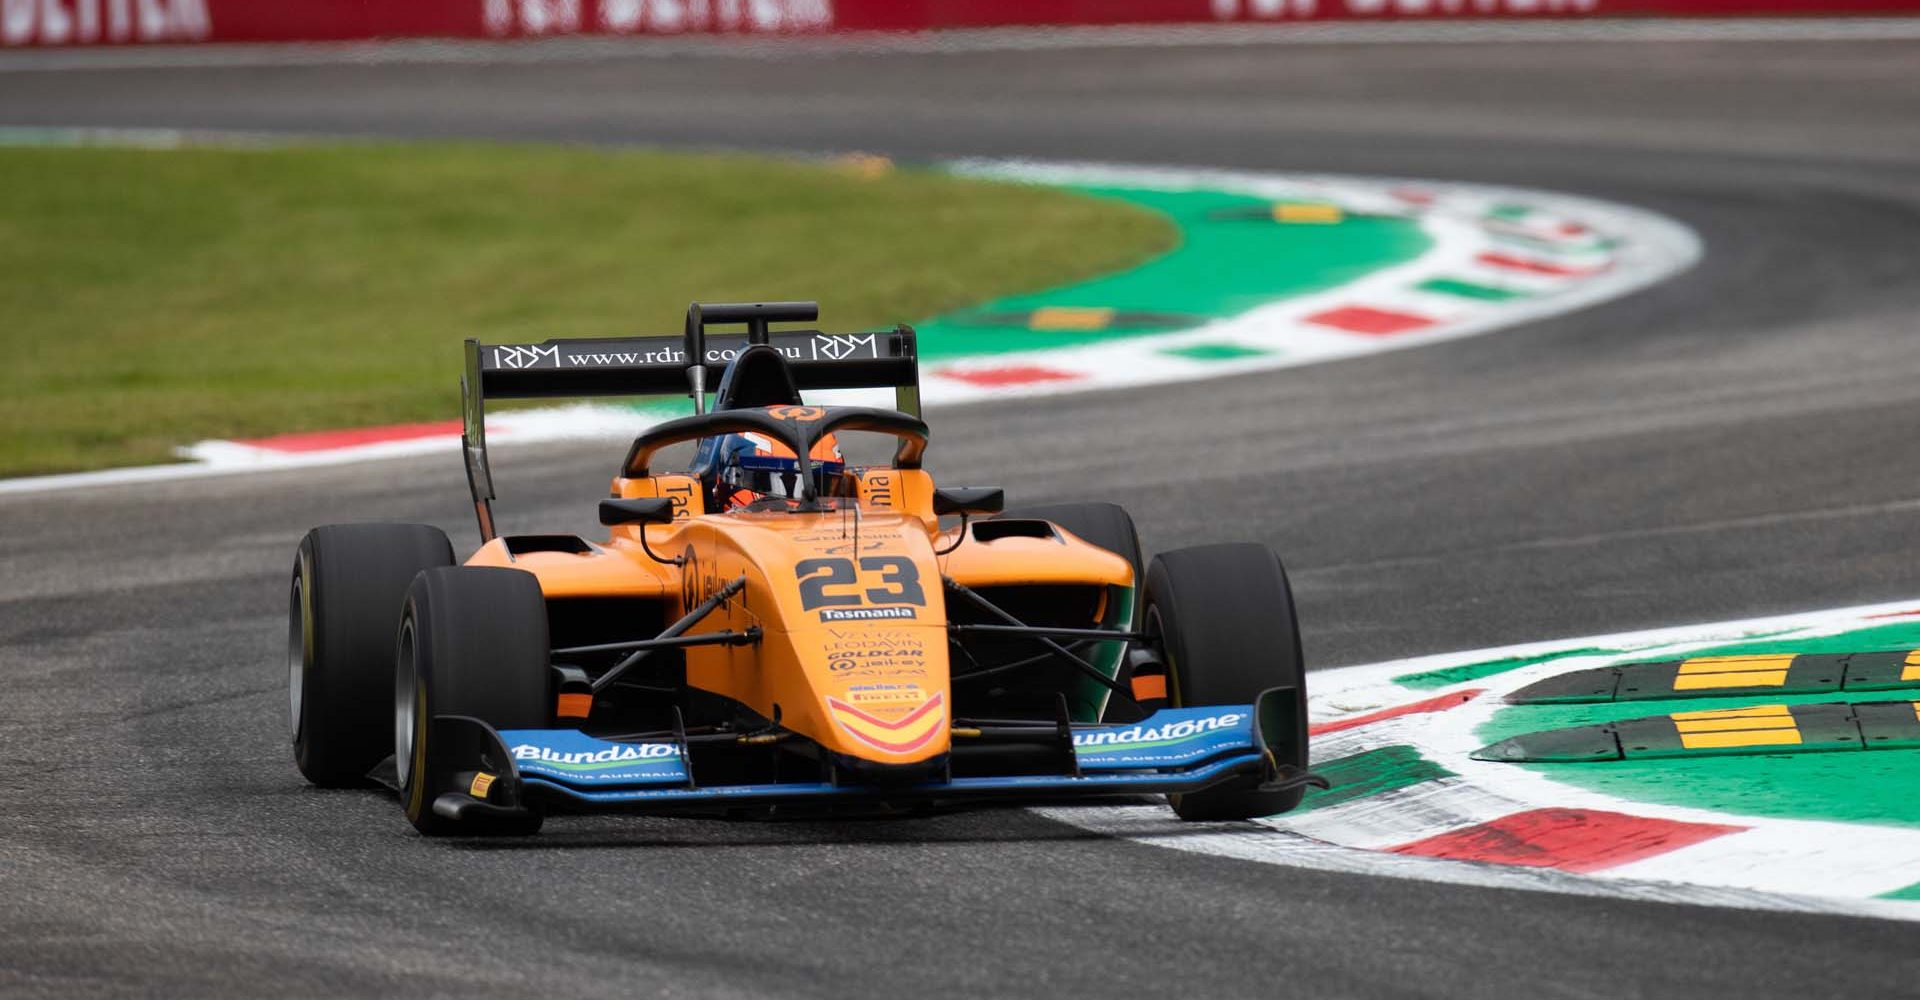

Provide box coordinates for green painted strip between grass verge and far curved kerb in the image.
[916,186,1432,361]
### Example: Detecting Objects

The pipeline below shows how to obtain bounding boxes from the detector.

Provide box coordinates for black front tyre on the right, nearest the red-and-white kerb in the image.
[1142,545,1308,820]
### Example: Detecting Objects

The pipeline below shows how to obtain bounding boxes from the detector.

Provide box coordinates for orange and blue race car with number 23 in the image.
[288,303,1325,835]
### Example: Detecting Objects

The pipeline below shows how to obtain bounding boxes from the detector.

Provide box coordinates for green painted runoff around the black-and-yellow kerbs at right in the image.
[1475,620,1920,825]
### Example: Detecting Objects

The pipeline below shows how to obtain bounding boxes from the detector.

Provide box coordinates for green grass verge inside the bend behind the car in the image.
[0,144,1175,476]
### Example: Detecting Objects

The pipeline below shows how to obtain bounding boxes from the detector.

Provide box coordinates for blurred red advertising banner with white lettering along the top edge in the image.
[0,0,1920,46]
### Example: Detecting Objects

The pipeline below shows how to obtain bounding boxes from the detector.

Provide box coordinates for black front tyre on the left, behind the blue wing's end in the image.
[388,566,551,837]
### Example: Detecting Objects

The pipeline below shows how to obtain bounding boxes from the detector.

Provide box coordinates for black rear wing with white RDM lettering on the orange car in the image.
[461,301,920,541]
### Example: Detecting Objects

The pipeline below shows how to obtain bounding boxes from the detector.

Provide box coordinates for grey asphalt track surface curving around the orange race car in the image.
[0,42,1920,998]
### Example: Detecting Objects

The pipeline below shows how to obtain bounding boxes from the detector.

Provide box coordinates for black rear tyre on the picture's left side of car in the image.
[286,524,453,789]
